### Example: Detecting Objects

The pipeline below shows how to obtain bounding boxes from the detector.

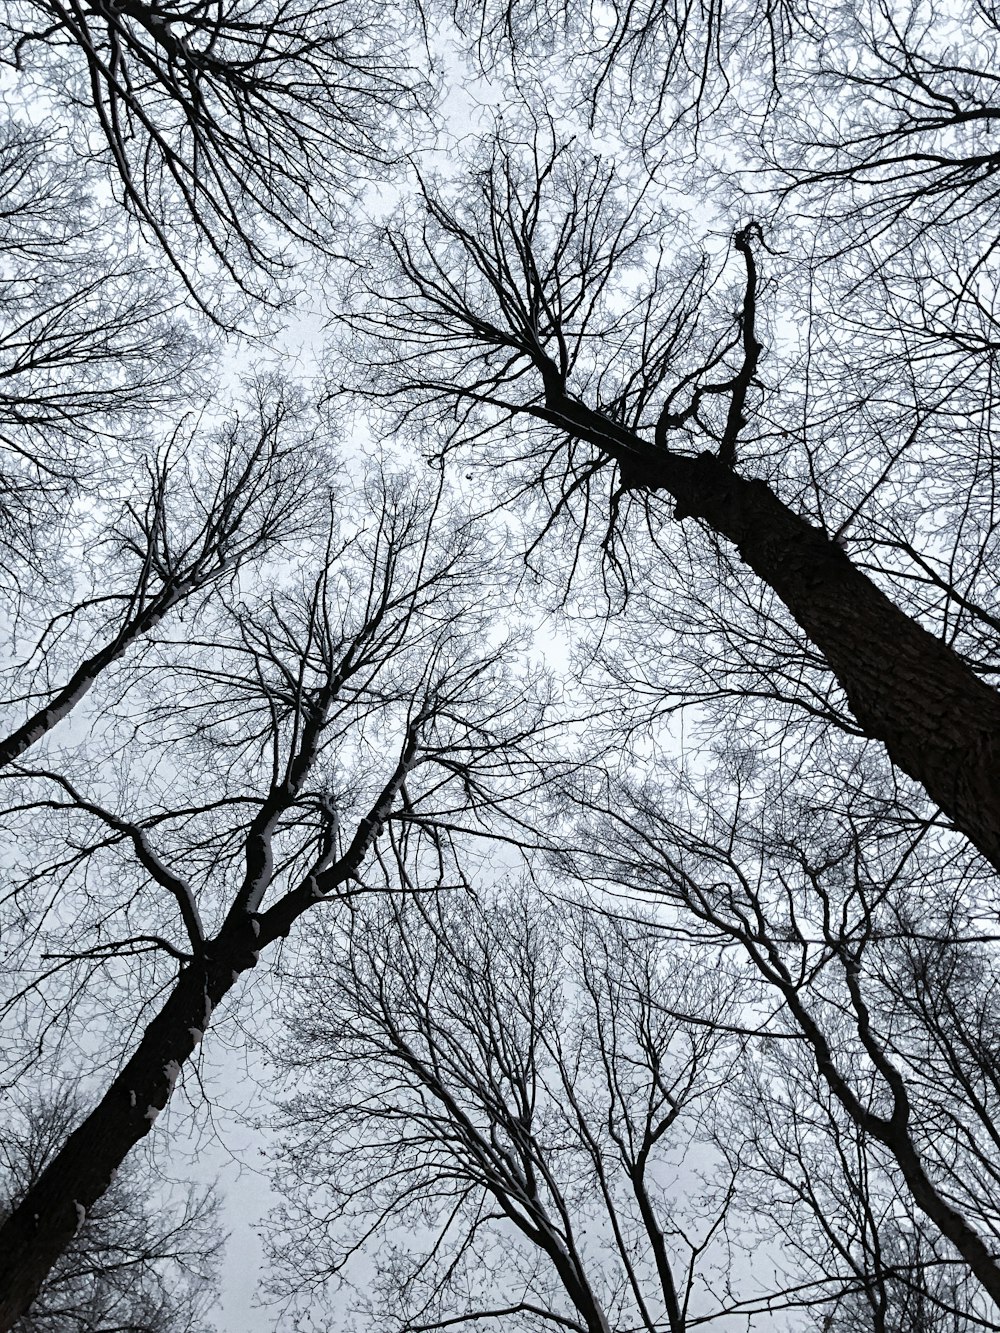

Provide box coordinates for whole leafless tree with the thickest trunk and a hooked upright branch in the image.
[326,114,1000,865]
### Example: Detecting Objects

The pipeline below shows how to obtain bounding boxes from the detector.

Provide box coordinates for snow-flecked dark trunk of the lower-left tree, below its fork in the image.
[0,921,260,1333]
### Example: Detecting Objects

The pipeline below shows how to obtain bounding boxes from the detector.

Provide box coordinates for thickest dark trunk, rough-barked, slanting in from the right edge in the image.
[549,391,1000,870]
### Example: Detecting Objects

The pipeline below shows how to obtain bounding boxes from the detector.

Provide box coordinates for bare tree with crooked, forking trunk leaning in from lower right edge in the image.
[557,765,1000,1301]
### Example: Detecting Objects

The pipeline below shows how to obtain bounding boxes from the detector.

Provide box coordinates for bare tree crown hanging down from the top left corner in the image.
[0,0,427,305]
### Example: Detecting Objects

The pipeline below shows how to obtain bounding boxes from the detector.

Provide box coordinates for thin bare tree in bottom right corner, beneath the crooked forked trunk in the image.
[719,997,995,1333]
